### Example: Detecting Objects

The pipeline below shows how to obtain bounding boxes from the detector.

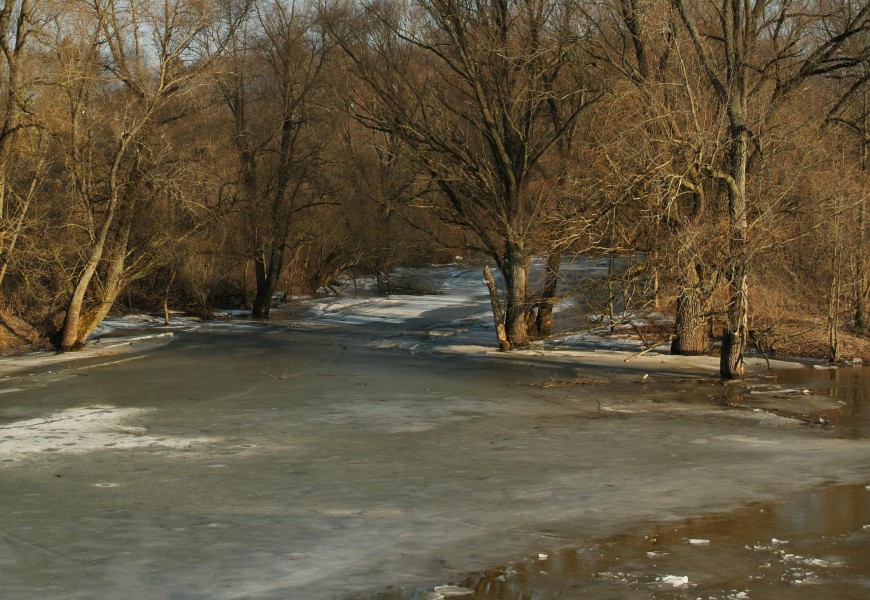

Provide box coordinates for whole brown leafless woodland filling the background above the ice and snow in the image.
[0,0,870,378]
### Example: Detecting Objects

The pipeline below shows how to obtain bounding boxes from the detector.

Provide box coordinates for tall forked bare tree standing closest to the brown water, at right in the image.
[672,0,870,379]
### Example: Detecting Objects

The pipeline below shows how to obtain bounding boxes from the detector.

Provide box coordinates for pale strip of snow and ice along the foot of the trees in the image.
[0,260,802,377]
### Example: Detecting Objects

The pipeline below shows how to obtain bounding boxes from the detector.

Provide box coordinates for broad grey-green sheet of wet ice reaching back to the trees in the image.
[0,264,870,600]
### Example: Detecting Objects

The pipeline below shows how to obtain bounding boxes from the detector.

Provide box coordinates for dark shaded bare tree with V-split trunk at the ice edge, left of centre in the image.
[219,0,329,318]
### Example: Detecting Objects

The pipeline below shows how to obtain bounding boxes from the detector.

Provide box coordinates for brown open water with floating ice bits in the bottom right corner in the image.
[372,485,870,600]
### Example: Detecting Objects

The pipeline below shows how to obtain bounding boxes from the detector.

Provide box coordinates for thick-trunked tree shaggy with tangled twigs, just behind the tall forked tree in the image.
[581,0,718,355]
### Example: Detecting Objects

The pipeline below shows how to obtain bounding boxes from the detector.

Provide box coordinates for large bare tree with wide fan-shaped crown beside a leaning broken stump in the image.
[332,0,597,348]
